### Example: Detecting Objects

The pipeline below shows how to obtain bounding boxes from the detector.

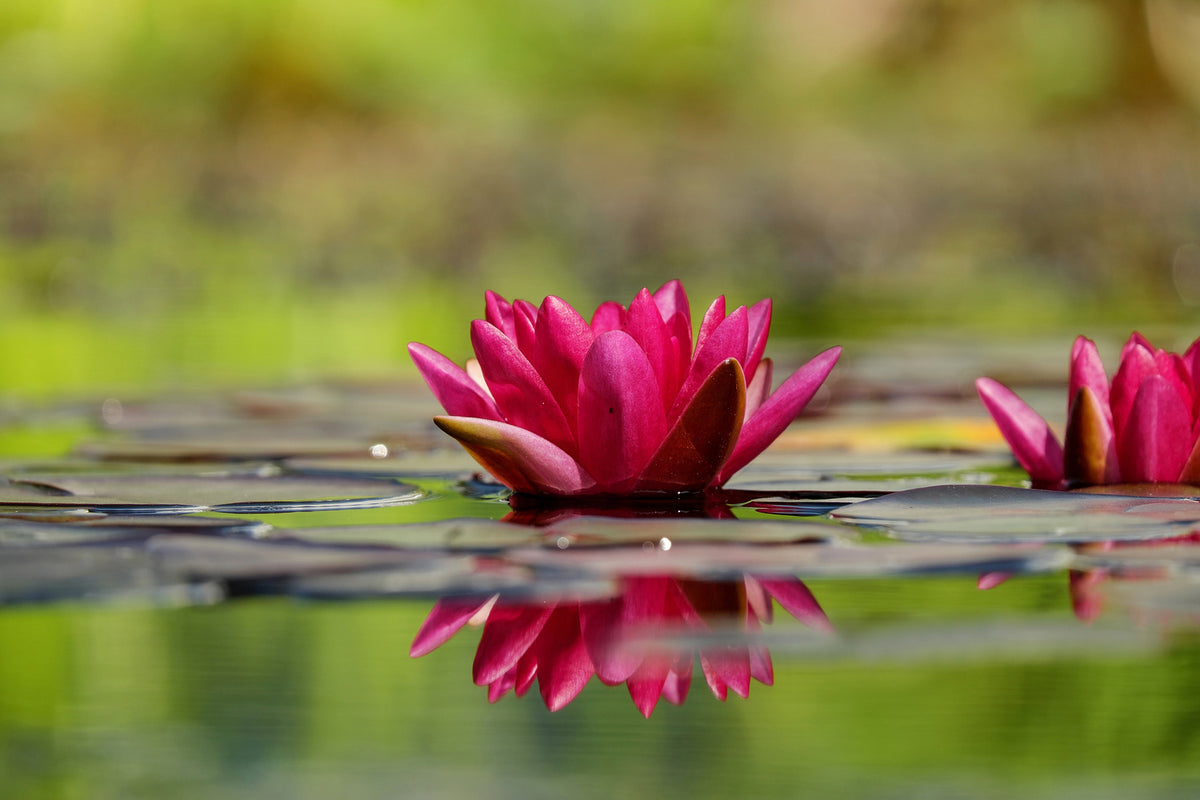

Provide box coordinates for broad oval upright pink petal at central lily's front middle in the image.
[580,331,666,493]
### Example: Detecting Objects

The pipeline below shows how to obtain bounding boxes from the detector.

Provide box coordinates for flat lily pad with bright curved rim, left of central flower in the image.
[0,474,424,513]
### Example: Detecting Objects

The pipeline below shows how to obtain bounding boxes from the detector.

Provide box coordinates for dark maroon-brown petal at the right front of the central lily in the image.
[635,359,745,492]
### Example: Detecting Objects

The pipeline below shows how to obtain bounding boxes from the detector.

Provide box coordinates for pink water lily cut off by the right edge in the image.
[976,332,1200,488]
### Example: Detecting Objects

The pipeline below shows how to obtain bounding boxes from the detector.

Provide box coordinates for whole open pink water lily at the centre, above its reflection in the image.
[408,281,841,495]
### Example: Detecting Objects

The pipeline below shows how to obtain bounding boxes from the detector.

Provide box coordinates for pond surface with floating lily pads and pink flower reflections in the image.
[0,352,1200,800]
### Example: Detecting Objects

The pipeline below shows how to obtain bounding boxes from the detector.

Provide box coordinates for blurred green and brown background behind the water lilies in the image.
[0,0,1200,397]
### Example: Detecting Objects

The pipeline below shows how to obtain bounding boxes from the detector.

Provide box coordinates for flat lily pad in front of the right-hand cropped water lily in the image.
[832,485,1200,542]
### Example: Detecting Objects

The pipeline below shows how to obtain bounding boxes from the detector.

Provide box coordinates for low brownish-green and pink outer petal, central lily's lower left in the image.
[433,416,596,495]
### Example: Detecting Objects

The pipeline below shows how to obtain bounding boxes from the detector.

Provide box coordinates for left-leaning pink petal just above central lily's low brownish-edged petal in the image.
[470,319,576,453]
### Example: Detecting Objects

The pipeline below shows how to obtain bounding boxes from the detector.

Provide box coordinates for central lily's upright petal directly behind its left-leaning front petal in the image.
[529,296,594,431]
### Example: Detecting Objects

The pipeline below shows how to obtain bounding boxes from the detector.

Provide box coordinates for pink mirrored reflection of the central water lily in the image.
[410,576,832,717]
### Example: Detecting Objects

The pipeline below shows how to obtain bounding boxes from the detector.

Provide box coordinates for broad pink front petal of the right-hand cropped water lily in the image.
[1117,375,1192,483]
